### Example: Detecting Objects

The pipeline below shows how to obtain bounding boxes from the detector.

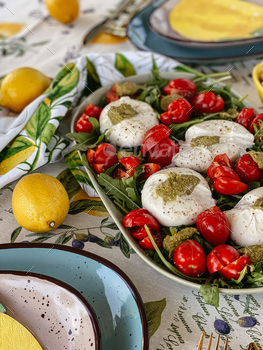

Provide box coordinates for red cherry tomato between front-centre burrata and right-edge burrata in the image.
[196,206,230,246]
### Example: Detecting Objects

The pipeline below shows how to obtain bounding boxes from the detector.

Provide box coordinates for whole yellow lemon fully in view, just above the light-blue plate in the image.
[12,173,69,233]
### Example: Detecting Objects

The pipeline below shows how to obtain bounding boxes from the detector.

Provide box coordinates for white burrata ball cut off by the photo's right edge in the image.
[224,187,263,247]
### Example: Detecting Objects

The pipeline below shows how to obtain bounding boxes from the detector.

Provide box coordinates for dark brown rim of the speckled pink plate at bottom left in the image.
[0,270,101,350]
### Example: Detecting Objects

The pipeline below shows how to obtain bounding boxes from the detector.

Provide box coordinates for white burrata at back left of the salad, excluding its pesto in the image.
[100,96,159,147]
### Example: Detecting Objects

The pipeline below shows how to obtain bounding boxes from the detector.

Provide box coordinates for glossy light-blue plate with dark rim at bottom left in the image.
[0,243,149,350]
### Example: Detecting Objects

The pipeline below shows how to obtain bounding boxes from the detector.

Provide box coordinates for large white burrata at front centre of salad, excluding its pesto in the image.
[142,168,215,227]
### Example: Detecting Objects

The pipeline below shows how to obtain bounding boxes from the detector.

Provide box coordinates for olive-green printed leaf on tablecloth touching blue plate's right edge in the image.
[144,298,166,337]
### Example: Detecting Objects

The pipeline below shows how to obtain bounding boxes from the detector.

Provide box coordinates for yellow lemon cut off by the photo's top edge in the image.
[45,0,79,23]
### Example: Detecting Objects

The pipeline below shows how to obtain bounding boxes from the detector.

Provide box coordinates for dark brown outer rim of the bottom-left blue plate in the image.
[0,242,149,350]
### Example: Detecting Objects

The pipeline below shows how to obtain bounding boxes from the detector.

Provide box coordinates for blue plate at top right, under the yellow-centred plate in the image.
[127,0,263,63]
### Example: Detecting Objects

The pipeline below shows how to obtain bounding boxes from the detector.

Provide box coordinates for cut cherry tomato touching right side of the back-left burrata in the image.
[160,98,193,125]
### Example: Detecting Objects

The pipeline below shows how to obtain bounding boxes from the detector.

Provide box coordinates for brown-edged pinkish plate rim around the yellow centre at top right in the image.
[148,0,263,48]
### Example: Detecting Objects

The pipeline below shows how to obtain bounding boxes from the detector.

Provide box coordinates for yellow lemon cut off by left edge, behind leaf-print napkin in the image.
[0,67,51,113]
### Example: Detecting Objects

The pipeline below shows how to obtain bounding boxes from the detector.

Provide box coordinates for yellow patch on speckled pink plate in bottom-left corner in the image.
[0,312,42,350]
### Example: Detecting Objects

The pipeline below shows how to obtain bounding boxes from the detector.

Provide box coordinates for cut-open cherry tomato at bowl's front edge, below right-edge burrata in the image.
[207,244,250,280]
